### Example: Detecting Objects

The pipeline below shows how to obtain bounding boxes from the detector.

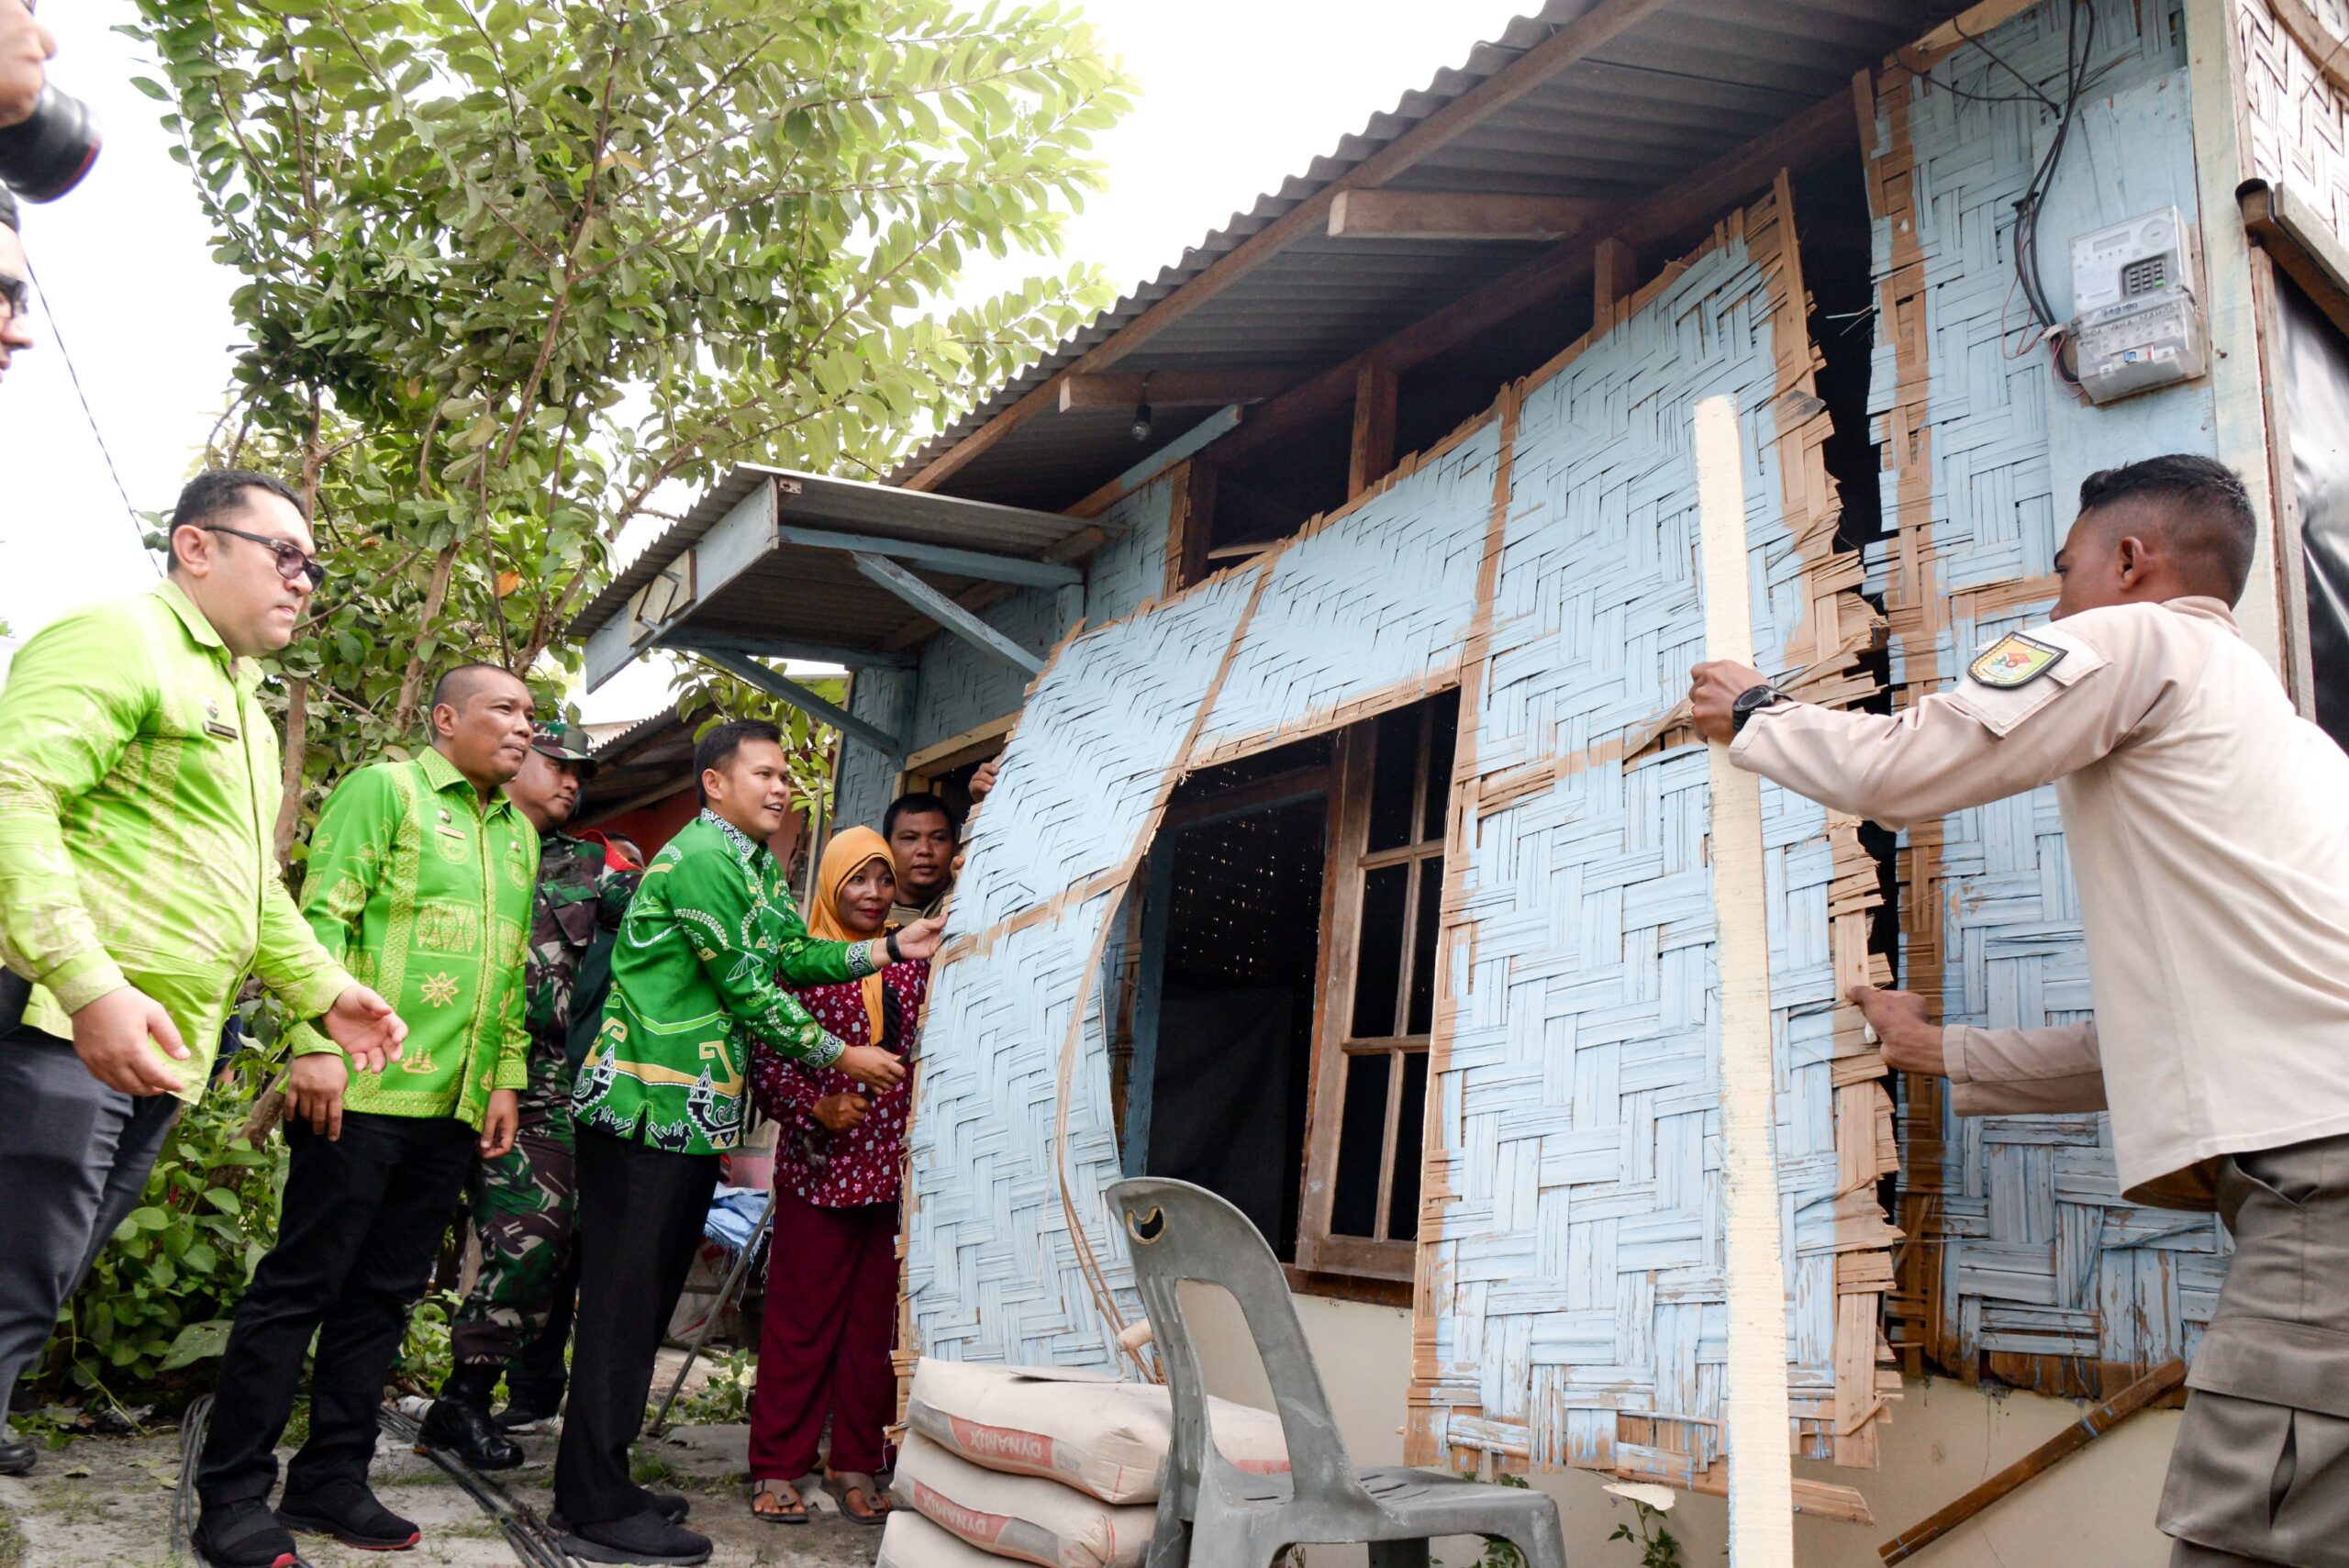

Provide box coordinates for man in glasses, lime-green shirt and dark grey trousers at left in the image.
[0,470,406,1474]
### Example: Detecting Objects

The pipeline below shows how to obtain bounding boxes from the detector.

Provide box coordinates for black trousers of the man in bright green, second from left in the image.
[195,1110,477,1509]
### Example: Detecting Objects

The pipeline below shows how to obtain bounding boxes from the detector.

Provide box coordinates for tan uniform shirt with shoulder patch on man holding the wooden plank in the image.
[1731,598,2349,1207]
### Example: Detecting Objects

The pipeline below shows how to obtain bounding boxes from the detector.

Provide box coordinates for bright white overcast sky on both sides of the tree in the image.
[0,0,1534,718]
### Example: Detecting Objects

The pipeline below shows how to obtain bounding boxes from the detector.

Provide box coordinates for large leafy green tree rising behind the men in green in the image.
[134,0,1128,845]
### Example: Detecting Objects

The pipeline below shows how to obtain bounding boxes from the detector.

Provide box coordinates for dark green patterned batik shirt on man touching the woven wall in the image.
[571,812,872,1155]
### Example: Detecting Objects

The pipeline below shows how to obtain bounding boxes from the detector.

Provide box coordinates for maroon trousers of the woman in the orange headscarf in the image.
[750,1188,897,1481]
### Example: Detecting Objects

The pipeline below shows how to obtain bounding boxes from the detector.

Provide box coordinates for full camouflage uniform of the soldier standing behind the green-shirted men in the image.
[449,833,641,1387]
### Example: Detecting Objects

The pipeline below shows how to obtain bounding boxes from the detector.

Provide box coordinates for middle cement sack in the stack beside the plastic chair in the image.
[890,1432,1158,1568]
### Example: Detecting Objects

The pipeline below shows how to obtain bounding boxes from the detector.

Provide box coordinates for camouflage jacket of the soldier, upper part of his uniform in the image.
[521,833,643,1106]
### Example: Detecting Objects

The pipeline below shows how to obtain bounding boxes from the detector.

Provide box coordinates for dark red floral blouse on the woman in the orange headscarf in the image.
[750,960,930,1209]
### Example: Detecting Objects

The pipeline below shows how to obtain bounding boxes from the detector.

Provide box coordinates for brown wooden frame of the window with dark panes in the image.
[1295,690,1459,1282]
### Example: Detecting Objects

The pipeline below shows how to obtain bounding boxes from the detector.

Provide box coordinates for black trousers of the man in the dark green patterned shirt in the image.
[554,1127,718,1523]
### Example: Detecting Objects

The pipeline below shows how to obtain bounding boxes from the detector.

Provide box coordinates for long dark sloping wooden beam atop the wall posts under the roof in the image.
[1203,92,1858,462]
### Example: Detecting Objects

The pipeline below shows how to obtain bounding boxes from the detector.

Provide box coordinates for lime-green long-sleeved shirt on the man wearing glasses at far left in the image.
[0,582,352,1101]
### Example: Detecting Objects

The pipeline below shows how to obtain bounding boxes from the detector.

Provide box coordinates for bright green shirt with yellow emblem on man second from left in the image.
[294,751,538,1127]
